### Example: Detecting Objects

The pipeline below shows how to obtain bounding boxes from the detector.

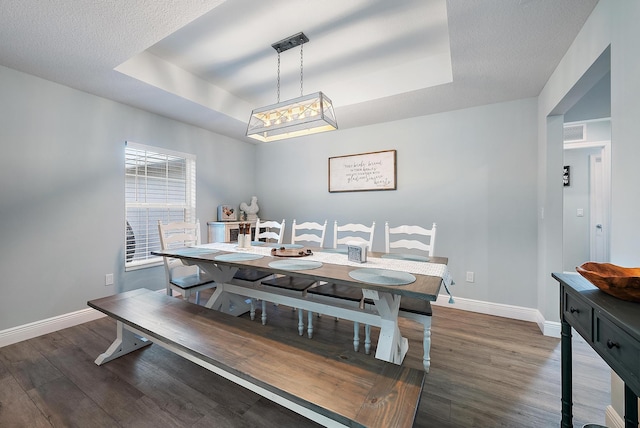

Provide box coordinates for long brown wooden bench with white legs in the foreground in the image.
[88,289,425,427]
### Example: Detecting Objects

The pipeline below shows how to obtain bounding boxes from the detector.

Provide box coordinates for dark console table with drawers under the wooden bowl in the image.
[551,273,640,428]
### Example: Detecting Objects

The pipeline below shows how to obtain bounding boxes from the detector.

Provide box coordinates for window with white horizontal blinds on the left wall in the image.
[125,142,196,270]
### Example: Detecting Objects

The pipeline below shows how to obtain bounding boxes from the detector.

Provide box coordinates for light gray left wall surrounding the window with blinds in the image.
[0,67,255,330]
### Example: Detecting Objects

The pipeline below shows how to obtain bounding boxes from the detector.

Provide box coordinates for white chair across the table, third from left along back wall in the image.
[307,221,376,346]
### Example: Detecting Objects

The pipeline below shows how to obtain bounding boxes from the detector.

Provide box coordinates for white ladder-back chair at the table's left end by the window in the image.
[158,220,216,304]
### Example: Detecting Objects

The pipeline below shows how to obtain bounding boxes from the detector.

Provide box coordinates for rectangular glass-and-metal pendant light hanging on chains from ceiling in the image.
[247,33,338,142]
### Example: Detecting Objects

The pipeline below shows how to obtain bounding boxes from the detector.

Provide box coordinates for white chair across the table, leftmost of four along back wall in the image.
[231,218,285,325]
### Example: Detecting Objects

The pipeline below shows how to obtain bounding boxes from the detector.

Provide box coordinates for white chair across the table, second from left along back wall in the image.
[262,219,327,337]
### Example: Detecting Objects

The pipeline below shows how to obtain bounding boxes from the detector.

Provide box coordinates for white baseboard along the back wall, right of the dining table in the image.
[432,294,560,337]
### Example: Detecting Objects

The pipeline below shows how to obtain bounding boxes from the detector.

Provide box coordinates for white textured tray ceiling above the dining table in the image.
[0,0,597,143]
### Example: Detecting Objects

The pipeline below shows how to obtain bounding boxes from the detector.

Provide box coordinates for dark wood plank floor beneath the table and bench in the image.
[0,292,610,428]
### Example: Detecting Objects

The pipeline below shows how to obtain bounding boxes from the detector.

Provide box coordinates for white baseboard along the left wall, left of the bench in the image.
[0,308,106,348]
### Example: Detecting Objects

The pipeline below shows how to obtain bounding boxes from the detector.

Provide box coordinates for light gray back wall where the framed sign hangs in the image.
[256,99,537,307]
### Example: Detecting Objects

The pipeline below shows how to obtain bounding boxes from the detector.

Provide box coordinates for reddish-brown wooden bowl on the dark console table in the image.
[576,262,640,302]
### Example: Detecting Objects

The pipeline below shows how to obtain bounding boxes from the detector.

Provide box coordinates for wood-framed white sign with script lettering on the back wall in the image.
[329,150,396,192]
